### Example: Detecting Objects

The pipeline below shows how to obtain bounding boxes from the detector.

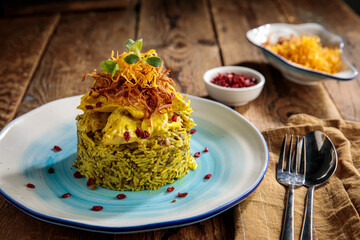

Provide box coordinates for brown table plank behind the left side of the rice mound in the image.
[17,9,136,115]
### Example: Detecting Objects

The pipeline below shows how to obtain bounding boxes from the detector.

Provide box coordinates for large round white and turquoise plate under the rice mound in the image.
[0,96,269,233]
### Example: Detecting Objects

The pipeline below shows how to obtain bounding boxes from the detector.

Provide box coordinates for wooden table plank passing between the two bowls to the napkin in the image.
[210,0,341,130]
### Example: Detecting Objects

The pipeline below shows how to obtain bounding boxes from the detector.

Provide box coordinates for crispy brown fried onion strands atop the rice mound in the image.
[82,67,175,119]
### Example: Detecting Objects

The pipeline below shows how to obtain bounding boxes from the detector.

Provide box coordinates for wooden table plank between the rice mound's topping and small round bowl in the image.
[138,0,221,96]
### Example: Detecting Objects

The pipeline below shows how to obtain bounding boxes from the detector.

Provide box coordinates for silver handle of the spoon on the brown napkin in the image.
[300,186,315,240]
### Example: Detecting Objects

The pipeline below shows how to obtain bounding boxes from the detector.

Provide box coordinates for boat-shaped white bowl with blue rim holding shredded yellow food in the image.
[246,23,358,85]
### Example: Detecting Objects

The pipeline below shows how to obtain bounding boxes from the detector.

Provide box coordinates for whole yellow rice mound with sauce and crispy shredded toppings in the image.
[74,45,197,191]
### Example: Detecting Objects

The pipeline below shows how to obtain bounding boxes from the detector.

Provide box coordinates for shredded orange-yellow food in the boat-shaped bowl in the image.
[264,35,343,74]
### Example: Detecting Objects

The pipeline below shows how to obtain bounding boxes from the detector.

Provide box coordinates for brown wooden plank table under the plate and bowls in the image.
[0,0,360,239]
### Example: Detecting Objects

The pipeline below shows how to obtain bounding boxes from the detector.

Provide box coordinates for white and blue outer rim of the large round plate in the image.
[0,94,269,233]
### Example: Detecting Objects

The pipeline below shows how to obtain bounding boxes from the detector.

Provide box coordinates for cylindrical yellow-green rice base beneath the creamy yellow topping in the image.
[74,115,197,191]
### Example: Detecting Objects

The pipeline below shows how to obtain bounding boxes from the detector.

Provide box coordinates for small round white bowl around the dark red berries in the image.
[203,66,265,107]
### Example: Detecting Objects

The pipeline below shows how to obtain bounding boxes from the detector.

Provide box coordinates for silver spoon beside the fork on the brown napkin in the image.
[301,131,338,240]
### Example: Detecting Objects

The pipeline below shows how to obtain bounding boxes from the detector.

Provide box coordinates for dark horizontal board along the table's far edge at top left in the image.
[0,0,137,17]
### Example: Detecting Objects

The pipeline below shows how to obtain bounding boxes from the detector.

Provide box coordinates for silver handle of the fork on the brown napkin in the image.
[281,185,294,240]
